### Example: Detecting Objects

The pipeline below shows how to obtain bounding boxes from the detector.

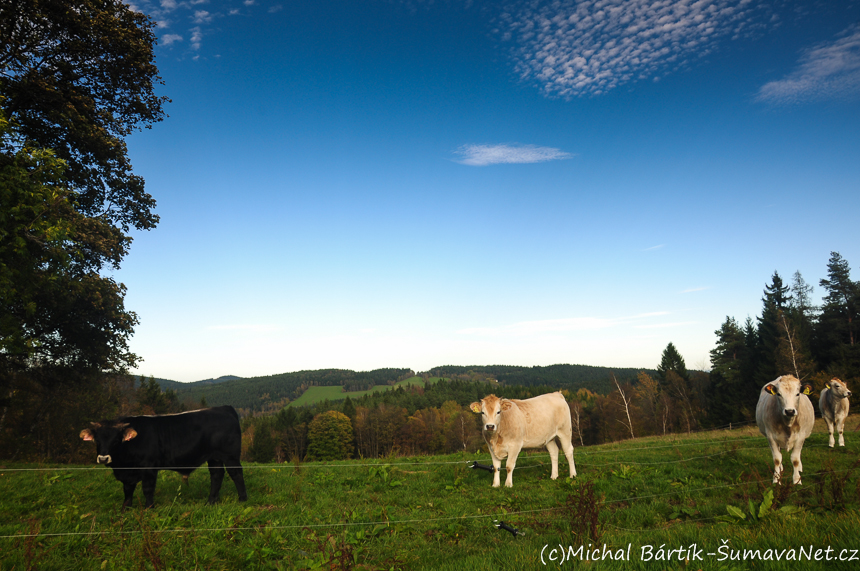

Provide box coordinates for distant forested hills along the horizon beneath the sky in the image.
[156,365,656,414]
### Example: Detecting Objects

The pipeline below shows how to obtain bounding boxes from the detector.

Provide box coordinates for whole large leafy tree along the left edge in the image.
[0,0,166,462]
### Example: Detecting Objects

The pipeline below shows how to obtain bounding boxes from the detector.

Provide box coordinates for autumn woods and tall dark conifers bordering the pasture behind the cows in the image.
[243,252,860,462]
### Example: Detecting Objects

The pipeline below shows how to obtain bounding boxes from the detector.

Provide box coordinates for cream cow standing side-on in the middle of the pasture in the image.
[469,393,576,488]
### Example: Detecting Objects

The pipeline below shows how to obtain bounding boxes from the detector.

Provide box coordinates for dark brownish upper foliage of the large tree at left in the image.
[0,0,167,235]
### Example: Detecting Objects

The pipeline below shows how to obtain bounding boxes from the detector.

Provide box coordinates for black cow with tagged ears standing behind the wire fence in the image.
[80,406,248,508]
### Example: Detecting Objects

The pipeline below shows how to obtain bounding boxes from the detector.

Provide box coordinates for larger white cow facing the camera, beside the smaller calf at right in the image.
[755,375,815,484]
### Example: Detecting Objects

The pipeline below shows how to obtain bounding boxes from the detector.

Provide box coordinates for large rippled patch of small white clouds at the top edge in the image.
[498,0,767,98]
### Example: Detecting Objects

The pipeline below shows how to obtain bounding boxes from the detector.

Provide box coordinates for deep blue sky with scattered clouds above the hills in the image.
[115,0,860,381]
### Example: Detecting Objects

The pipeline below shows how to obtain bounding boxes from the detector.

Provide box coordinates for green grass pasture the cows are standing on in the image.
[0,416,860,571]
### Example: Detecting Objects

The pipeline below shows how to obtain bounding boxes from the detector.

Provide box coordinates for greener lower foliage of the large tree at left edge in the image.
[0,115,137,372]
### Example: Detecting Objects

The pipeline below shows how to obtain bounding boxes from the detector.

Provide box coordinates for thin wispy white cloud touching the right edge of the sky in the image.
[757,25,860,104]
